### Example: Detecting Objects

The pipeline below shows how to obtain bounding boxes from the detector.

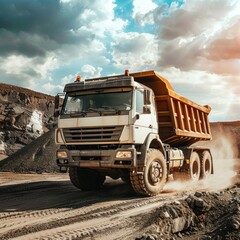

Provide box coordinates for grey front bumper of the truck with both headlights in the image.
[56,147,137,169]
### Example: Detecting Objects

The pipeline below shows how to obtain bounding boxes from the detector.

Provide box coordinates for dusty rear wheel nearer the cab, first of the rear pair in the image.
[189,152,201,181]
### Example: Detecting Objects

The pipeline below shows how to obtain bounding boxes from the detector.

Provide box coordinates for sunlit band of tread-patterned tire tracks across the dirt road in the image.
[0,194,183,239]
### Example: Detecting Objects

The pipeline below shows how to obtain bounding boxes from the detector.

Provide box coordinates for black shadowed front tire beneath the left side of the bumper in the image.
[69,167,106,191]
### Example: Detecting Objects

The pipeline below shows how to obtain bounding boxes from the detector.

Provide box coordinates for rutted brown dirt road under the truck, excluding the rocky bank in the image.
[0,173,186,240]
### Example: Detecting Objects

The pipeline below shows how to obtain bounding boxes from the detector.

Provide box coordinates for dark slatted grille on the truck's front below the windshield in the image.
[63,126,123,142]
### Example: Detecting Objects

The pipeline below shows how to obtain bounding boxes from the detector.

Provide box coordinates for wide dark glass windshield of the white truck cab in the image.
[62,88,132,117]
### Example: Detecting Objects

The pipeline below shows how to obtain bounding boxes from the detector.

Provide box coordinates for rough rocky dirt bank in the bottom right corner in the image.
[136,184,240,240]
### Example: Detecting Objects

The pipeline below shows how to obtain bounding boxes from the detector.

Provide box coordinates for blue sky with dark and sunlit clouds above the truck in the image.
[0,0,240,121]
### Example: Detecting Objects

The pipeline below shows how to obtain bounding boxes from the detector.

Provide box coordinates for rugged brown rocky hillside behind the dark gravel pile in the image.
[0,83,54,158]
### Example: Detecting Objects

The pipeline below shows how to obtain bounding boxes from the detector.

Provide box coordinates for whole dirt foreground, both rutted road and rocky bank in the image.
[0,172,240,240]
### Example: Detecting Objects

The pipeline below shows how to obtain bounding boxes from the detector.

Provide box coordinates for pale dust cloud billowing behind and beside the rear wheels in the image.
[164,129,239,192]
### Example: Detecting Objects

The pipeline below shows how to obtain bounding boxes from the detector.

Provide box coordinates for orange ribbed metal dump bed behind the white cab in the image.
[130,71,211,147]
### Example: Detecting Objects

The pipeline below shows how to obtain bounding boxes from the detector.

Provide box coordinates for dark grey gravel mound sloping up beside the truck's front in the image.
[0,129,58,173]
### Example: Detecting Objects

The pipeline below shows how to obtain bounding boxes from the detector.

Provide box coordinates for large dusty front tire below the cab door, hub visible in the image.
[130,148,167,196]
